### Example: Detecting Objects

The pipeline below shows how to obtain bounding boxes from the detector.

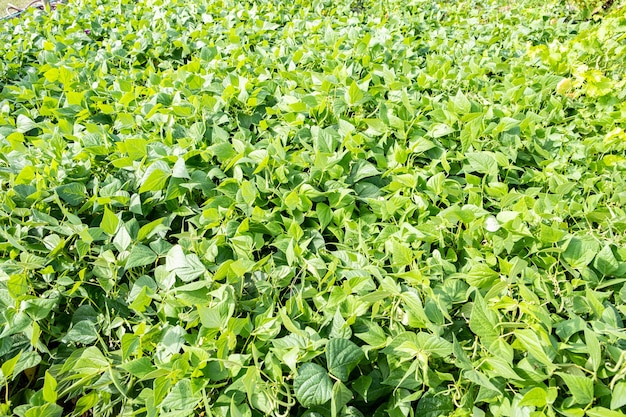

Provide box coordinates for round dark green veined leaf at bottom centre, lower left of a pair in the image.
[293,363,333,408]
